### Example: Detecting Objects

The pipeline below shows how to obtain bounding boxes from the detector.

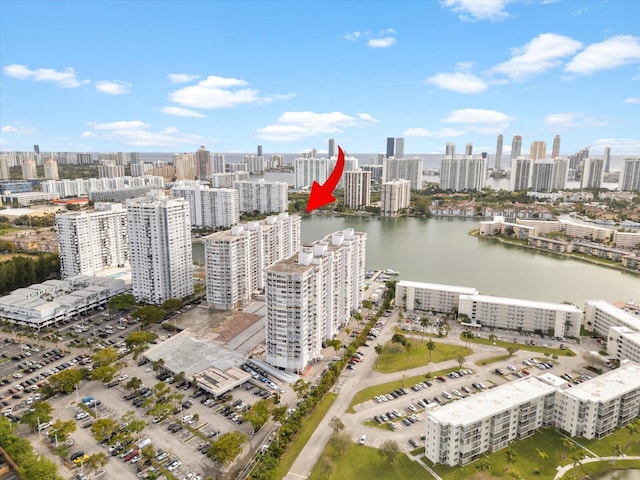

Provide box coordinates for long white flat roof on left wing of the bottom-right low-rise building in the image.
[429,377,556,425]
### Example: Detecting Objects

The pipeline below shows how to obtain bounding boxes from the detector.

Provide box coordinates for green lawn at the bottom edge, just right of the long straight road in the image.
[308,436,429,480]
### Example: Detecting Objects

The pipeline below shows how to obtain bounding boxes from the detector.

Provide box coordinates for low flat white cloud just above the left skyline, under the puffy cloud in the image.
[81,120,203,147]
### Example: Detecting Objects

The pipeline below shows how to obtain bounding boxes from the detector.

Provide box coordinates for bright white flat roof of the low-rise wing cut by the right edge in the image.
[564,360,640,402]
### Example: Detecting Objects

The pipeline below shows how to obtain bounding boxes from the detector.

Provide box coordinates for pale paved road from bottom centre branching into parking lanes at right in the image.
[283,312,598,480]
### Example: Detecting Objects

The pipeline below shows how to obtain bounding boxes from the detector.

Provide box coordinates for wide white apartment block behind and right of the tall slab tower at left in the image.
[171,181,240,228]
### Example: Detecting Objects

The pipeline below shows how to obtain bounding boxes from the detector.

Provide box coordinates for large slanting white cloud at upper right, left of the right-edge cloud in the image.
[489,33,582,80]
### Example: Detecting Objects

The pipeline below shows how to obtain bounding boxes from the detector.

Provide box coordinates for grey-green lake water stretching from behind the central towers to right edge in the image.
[194,215,640,307]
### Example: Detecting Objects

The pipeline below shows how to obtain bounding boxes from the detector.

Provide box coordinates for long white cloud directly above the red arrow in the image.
[257,111,378,142]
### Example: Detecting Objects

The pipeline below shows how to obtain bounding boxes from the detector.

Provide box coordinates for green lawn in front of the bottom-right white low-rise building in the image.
[422,429,587,480]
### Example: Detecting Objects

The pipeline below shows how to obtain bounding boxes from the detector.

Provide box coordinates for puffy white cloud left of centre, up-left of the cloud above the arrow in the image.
[169,75,272,109]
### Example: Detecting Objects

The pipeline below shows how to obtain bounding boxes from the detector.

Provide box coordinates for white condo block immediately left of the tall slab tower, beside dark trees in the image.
[56,203,129,278]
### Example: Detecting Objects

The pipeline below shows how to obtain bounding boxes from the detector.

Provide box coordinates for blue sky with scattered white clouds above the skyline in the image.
[0,0,640,155]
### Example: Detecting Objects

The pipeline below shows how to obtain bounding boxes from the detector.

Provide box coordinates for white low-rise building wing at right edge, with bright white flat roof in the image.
[555,362,640,439]
